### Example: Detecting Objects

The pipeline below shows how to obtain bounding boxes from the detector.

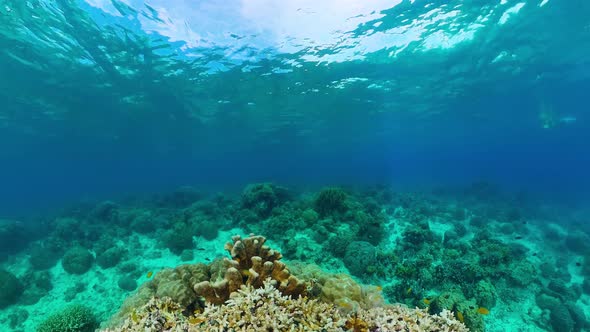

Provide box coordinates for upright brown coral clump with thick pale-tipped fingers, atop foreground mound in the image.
[194,235,307,304]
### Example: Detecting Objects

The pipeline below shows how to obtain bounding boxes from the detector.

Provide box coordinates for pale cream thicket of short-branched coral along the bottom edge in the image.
[104,279,468,332]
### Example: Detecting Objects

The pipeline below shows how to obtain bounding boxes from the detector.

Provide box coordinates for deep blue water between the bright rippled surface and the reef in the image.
[0,1,590,216]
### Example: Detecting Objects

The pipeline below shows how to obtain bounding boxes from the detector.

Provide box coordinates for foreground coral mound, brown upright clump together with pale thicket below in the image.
[107,235,467,332]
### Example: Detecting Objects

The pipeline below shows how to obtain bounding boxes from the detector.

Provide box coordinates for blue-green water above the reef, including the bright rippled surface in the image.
[0,0,590,330]
